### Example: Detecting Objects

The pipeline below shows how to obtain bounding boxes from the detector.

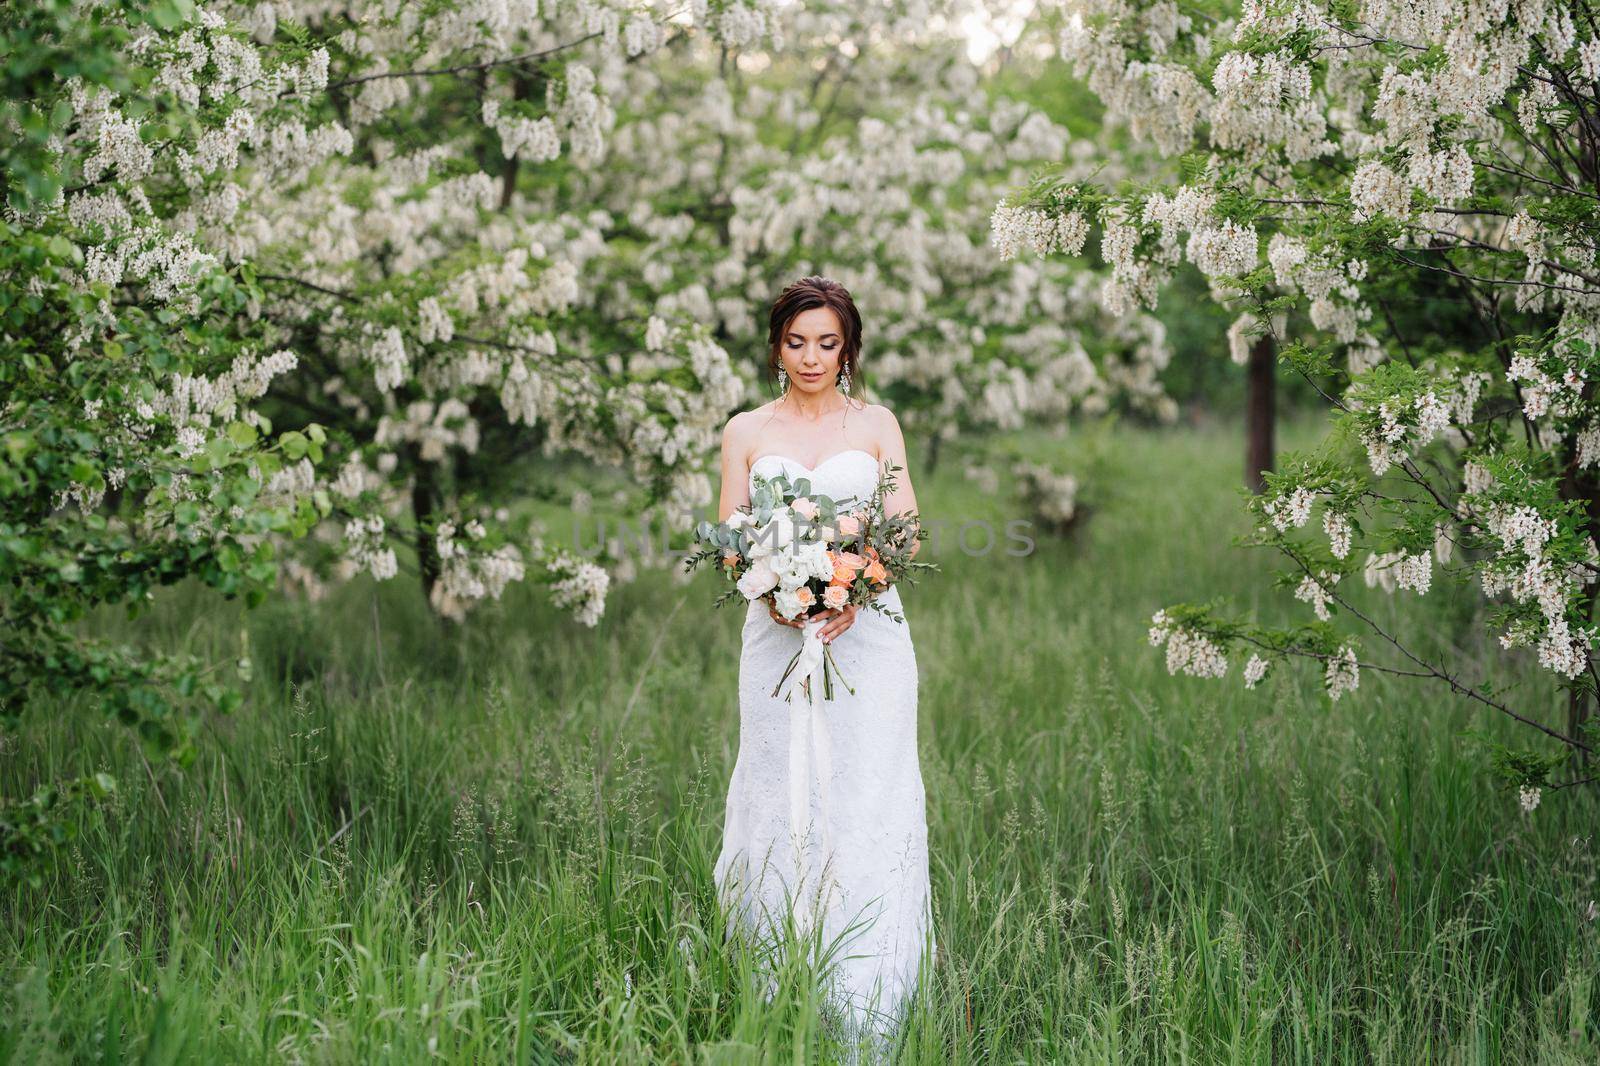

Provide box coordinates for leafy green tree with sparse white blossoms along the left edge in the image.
[0,0,345,879]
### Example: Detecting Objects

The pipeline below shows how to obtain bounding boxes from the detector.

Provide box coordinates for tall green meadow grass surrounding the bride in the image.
[0,429,1600,1064]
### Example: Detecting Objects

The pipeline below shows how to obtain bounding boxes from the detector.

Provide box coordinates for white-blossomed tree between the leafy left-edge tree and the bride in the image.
[178,2,784,624]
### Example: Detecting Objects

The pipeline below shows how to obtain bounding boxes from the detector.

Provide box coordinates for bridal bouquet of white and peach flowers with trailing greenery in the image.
[685,466,938,699]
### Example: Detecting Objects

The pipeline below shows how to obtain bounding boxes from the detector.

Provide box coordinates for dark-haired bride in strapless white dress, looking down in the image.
[715,277,934,1045]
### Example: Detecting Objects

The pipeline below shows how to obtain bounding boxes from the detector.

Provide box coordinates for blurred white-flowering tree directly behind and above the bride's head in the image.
[537,3,1173,489]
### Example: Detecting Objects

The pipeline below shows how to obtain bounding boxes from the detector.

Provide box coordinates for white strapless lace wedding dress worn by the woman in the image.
[715,448,934,1047]
